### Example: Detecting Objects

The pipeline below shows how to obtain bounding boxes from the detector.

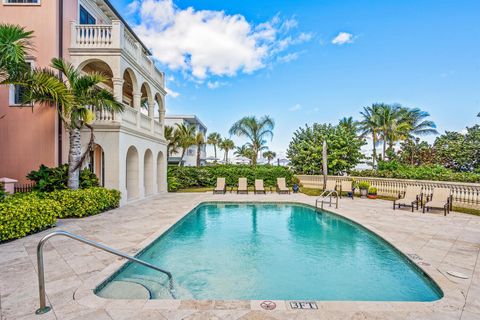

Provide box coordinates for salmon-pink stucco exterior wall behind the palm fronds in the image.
[0,1,58,183]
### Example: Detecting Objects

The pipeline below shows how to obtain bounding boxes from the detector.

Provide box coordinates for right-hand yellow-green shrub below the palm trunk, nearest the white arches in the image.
[42,187,120,218]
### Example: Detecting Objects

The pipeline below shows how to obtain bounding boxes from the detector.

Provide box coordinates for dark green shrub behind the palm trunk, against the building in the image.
[27,164,98,192]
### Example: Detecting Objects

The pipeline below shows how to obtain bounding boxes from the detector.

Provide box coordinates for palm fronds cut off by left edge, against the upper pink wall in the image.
[0,24,33,83]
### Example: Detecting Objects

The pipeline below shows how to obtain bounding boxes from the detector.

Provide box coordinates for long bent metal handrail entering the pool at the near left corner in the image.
[35,230,175,314]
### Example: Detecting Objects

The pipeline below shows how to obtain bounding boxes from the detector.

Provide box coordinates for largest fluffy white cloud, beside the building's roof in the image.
[135,0,312,80]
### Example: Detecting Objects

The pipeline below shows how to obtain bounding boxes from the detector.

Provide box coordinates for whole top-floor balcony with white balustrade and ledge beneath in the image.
[70,20,165,88]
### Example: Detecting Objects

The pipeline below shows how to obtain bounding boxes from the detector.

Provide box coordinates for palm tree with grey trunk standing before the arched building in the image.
[22,58,124,190]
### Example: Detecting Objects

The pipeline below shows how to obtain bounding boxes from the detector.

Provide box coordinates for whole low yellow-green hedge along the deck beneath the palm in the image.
[0,187,120,242]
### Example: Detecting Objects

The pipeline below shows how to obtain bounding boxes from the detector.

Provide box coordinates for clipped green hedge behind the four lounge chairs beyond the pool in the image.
[168,165,293,191]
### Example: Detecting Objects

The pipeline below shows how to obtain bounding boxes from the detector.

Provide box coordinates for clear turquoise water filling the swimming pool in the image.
[96,203,442,301]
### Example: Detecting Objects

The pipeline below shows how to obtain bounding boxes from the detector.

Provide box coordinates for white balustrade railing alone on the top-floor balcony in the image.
[70,20,165,87]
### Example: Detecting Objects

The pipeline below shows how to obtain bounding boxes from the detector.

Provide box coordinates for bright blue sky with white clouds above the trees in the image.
[111,0,480,158]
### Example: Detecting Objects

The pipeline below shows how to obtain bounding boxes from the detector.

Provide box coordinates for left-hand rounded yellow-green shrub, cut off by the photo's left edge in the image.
[0,192,61,242]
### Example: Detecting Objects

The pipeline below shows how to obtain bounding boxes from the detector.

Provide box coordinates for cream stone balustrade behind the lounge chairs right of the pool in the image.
[297,175,480,208]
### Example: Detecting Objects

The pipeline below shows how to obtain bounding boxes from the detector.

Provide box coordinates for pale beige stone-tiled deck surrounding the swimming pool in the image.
[0,193,480,320]
